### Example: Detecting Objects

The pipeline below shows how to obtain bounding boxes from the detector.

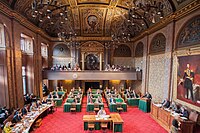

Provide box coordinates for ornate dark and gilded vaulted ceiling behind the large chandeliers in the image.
[2,0,194,37]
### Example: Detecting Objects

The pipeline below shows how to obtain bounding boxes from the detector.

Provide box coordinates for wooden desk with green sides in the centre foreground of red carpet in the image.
[83,113,124,133]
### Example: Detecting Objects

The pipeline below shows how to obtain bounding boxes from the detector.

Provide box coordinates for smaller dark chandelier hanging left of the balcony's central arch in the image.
[58,31,81,49]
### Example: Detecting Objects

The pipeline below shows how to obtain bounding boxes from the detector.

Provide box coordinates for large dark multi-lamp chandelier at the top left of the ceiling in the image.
[31,0,68,24]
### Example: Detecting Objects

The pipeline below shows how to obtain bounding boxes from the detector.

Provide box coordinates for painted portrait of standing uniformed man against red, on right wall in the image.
[177,55,200,107]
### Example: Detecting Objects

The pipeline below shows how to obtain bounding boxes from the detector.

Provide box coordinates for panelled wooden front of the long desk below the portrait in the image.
[151,104,194,133]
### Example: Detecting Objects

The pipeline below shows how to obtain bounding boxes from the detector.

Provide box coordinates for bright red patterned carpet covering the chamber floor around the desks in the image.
[34,97,167,133]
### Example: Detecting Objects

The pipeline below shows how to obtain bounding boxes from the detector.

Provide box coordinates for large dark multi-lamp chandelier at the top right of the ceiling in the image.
[128,0,164,25]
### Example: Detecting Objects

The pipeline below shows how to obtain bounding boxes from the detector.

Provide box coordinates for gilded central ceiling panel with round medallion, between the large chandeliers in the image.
[80,6,106,36]
